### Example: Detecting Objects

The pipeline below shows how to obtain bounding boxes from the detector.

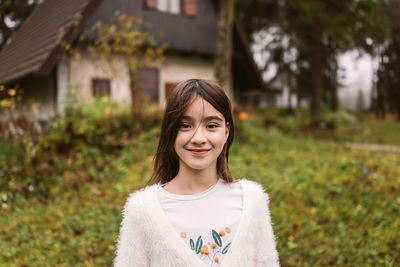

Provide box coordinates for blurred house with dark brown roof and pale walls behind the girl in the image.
[0,0,264,120]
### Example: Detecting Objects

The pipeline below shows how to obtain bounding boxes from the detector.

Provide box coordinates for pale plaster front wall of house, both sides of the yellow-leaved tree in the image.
[69,52,215,106]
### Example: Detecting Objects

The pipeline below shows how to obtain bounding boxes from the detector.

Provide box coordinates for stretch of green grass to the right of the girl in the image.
[232,116,400,266]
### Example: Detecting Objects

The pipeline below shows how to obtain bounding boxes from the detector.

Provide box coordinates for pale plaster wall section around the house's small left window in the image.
[69,52,131,104]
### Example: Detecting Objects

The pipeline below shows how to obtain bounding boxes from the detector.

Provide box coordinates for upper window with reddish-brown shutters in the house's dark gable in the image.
[145,0,197,16]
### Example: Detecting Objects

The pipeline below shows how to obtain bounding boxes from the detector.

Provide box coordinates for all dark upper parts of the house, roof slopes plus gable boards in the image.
[0,0,264,89]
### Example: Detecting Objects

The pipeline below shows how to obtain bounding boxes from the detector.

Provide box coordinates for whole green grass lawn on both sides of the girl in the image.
[0,117,400,266]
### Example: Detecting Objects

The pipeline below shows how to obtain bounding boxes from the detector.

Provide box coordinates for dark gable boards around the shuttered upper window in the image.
[87,0,218,56]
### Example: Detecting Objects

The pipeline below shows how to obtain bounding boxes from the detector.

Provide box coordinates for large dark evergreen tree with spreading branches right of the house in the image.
[237,0,389,126]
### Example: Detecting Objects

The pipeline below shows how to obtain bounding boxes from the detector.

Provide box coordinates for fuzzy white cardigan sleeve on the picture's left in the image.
[114,194,150,267]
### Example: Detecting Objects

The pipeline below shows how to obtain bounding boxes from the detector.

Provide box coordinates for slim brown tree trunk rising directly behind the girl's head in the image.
[215,0,234,100]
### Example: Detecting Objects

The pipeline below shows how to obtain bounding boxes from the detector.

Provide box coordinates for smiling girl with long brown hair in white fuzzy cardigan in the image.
[114,79,279,267]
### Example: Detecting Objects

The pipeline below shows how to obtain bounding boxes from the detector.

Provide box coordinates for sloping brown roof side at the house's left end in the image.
[0,0,101,83]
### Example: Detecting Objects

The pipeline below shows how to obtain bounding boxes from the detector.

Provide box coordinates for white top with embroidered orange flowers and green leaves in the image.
[157,179,243,267]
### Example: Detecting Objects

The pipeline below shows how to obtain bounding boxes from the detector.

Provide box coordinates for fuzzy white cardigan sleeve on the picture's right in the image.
[256,185,280,267]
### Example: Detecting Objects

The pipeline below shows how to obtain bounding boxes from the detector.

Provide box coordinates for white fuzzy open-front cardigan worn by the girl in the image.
[114,179,279,267]
